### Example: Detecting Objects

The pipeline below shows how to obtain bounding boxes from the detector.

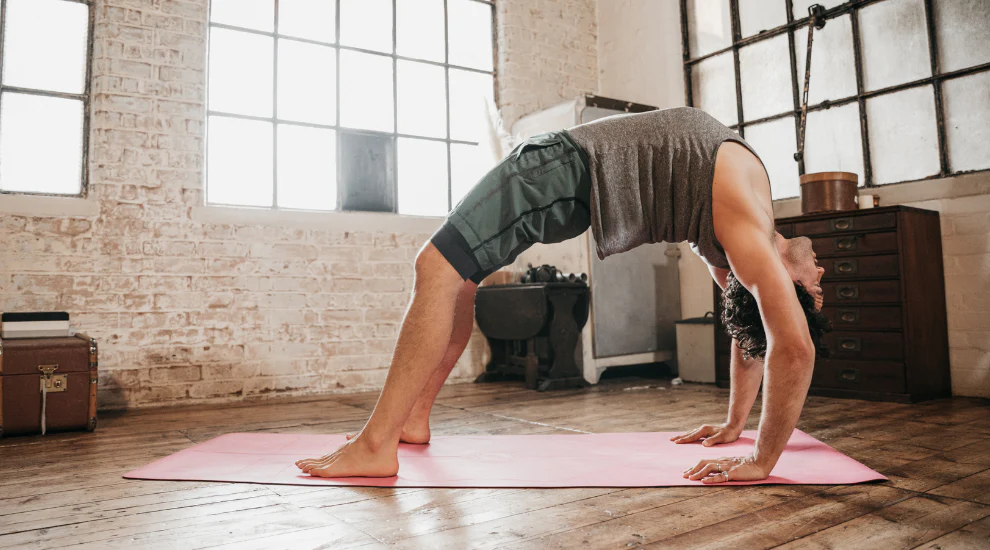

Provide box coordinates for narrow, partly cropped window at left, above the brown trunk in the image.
[0,0,92,195]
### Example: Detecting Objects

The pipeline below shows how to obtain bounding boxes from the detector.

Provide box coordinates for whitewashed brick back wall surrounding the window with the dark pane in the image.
[0,0,595,408]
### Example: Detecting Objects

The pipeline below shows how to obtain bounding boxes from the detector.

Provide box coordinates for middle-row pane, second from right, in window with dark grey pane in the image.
[396,59,447,138]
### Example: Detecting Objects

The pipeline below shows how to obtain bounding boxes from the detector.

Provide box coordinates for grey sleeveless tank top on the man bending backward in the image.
[567,107,759,269]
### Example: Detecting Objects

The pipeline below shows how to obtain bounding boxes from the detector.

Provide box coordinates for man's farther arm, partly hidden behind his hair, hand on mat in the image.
[671,267,763,447]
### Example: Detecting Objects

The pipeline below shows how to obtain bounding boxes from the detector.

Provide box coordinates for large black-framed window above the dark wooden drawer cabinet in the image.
[681,0,990,199]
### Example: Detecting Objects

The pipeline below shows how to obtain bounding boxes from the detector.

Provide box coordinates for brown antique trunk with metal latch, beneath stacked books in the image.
[0,334,97,437]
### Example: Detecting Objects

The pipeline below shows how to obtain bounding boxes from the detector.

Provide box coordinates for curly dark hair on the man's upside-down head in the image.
[722,273,832,359]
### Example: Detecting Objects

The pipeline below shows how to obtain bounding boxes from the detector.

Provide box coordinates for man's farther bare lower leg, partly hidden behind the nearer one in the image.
[347,281,478,444]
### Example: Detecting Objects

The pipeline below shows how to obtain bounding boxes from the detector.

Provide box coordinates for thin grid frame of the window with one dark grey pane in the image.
[203,0,499,213]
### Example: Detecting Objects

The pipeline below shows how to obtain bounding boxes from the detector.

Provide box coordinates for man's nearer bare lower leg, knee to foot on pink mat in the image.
[296,243,465,477]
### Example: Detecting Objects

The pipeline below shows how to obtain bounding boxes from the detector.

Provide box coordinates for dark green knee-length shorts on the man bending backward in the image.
[430,131,591,283]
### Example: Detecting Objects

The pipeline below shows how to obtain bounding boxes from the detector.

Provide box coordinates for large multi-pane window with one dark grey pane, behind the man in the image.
[206,0,494,216]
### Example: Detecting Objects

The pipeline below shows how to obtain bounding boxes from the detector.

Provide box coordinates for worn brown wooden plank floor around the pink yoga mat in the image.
[0,379,990,550]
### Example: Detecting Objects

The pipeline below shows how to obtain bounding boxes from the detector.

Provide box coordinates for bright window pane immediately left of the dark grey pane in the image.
[278,124,337,210]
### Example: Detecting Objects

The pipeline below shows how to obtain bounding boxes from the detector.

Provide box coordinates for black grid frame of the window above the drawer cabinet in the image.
[681,0,990,192]
